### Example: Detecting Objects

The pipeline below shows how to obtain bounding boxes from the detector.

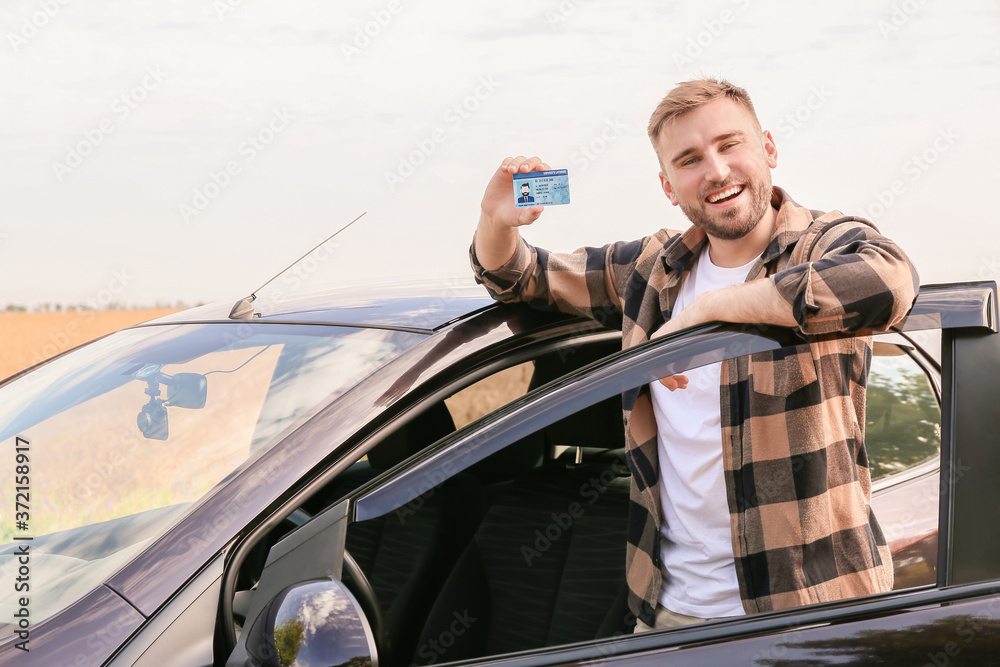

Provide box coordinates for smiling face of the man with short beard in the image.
[656,98,778,240]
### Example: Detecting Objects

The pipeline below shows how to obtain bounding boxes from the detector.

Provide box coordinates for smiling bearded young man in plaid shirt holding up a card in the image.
[472,80,919,631]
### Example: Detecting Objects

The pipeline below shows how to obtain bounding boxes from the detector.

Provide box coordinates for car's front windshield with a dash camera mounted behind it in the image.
[0,323,423,636]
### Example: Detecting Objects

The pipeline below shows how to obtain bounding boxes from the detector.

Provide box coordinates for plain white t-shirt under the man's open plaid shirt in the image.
[650,248,757,618]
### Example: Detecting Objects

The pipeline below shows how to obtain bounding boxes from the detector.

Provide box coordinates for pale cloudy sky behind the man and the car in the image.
[0,0,1000,309]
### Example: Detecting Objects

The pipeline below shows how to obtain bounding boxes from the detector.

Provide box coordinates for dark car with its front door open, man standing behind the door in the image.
[0,283,1000,667]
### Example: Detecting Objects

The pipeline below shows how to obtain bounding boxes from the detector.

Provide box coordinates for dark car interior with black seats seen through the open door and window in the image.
[232,334,936,667]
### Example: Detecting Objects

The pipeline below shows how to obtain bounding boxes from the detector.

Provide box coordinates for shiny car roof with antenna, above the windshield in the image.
[135,278,495,332]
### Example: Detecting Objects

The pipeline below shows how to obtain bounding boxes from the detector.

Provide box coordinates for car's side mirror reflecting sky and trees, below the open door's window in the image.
[226,579,378,667]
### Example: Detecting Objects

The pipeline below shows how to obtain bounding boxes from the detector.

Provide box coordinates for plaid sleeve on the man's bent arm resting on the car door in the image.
[771,219,920,336]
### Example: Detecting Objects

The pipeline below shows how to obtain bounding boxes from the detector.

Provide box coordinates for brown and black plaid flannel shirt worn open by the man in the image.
[471,187,919,626]
